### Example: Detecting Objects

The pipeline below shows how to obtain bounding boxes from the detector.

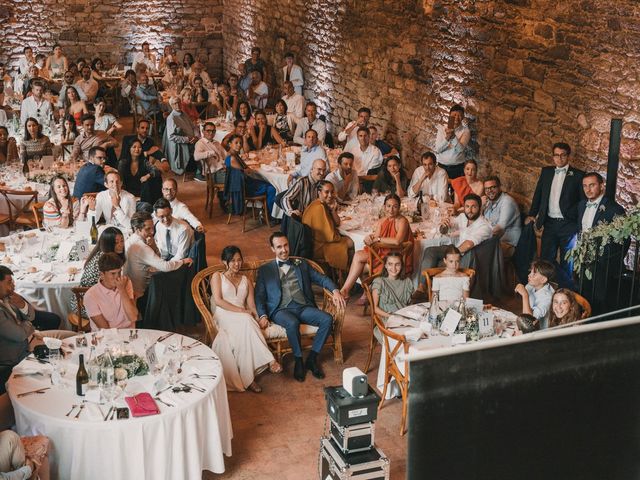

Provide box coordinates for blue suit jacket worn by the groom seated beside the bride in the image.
[255,260,337,317]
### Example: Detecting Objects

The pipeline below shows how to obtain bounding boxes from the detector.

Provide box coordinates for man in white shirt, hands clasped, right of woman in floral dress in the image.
[89,170,136,228]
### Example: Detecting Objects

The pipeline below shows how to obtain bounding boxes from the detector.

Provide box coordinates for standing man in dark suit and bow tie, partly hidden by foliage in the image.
[578,172,628,315]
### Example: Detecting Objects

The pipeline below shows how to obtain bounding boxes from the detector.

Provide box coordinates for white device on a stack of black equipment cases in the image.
[319,367,389,480]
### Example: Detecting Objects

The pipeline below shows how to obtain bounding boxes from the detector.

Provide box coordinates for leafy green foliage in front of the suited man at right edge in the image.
[566,206,640,280]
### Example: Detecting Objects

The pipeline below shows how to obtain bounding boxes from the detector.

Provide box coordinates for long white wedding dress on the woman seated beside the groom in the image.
[211,274,274,392]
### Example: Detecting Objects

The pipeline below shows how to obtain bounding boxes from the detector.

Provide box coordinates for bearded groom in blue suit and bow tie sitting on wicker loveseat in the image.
[256,232,344,382]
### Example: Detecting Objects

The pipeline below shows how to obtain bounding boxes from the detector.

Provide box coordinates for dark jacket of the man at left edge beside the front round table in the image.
[0,302,35,366]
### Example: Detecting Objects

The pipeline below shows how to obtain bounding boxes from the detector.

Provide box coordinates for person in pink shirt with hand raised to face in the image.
[84,253,139,332]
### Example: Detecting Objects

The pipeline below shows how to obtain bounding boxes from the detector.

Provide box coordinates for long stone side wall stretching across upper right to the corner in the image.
[223,0,640,205]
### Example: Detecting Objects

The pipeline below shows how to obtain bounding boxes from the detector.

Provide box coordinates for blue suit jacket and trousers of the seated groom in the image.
[255,260,337,357]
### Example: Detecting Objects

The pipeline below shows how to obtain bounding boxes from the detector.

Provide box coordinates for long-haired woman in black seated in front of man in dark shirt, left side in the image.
[118,139,162,205]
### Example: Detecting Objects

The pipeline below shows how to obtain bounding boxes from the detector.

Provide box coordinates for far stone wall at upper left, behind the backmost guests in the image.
[0,0,222,79]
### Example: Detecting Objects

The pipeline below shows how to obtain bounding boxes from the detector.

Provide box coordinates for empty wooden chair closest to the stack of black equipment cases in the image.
[362,279,409,435]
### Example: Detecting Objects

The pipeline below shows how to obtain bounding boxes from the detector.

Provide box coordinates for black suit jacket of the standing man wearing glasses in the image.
[529,166,584,228]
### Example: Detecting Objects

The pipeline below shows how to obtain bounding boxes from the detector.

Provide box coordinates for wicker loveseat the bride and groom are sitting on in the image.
[191,257,344,365]
